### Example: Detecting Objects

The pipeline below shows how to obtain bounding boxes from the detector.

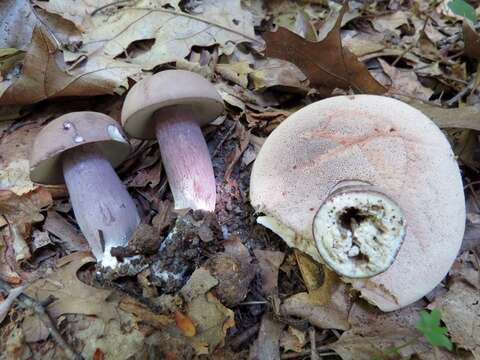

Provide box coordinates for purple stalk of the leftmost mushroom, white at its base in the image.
[63,144,140,269]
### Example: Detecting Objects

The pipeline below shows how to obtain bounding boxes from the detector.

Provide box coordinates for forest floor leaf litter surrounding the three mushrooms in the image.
[0,0,480,359]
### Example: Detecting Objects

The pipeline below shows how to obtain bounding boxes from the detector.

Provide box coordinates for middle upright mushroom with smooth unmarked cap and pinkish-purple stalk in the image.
[122,70,224,211]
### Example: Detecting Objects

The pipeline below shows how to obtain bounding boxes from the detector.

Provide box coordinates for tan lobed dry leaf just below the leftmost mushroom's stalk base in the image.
[25,252,117,320]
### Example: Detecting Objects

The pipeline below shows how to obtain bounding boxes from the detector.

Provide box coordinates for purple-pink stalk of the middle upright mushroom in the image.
[153,107,216,212]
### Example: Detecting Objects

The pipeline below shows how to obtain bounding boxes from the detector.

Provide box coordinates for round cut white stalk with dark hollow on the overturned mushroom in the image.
[313,181,406,278]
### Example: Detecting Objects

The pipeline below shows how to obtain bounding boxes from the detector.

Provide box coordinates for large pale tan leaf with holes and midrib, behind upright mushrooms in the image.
[43,0,259,69]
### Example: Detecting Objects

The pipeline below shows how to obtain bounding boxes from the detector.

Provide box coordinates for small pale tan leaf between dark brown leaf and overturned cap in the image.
[378,59,433,101]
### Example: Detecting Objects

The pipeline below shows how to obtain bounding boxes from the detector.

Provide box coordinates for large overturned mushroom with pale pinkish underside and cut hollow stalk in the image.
[250,95,465,311]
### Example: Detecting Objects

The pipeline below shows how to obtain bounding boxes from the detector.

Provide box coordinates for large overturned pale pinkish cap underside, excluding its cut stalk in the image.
[250,95,465,311]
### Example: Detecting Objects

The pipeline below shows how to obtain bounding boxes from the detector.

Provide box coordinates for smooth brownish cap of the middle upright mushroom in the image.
[122,70,224,139]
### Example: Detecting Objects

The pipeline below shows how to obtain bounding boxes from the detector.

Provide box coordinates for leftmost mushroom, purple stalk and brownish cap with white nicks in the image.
[30,111,140,268]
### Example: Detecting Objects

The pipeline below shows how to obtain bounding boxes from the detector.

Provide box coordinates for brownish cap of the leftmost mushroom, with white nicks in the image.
[30,111,131,185]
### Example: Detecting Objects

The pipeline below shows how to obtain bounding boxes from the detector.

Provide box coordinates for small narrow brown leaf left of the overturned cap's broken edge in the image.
[253,249,285,296]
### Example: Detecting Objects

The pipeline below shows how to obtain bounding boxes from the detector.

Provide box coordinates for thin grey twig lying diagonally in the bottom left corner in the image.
[0,280,84,360]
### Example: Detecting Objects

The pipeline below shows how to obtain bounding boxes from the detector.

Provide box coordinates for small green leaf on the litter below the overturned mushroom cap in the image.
[417,309,453,351]
